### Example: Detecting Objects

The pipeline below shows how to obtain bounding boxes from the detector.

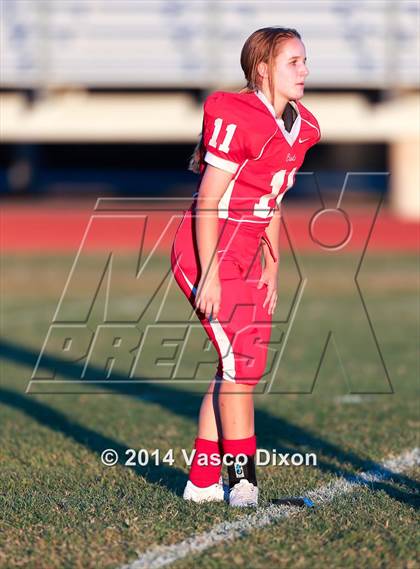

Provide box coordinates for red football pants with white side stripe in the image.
[171,207,274,385]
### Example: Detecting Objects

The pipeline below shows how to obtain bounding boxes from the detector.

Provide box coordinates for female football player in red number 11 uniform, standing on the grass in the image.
[171,27,320,506]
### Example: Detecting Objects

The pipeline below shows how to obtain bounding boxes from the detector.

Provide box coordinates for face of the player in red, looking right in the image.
[273,38,309,100]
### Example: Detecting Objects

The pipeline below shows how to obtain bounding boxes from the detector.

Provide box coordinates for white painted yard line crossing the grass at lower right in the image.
[119,448,420,569]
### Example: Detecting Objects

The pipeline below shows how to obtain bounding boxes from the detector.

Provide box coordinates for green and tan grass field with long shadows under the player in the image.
[0,254,419,569]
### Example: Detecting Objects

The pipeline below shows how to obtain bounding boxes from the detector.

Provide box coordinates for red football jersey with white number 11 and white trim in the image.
[201,91,320,227]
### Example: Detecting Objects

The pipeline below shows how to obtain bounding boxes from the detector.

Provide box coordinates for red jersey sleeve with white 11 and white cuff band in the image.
[203,92,248,174]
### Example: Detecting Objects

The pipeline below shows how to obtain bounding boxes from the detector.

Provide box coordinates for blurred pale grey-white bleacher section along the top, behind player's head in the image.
[0,0,419,89]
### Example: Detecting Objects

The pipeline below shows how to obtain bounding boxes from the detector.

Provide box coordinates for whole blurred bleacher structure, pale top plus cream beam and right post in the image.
[0,0,420,219]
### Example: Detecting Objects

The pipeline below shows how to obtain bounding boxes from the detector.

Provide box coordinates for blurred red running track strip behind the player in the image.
[1,202,420,254]
